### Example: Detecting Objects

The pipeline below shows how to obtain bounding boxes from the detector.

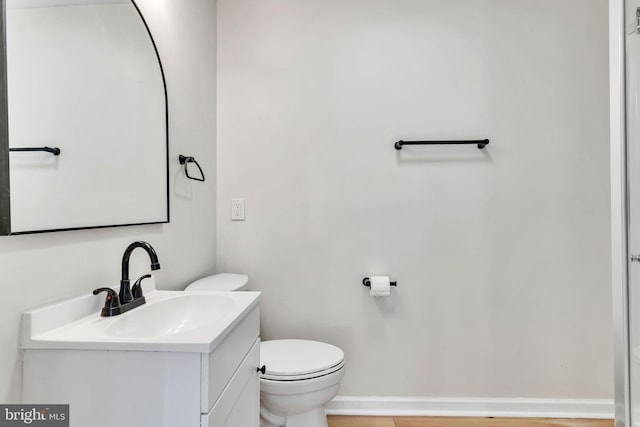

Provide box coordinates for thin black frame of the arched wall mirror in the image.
[0,0,171,236]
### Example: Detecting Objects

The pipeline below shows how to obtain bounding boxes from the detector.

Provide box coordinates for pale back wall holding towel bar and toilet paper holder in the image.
[217,0,613,399]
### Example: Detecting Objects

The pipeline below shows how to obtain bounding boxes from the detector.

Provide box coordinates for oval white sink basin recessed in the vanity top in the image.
[105,294,235,338]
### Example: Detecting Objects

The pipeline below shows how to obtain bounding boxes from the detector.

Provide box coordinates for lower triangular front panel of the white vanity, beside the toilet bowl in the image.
[200,340,260,427]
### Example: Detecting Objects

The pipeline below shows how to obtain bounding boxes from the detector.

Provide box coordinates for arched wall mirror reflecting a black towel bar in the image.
[0,0,169,234]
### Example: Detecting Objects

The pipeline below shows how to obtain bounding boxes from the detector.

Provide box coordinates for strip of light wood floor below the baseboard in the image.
[328,416,613,427]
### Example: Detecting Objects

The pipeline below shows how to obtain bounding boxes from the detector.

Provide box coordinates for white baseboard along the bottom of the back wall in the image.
[327,396,614,419]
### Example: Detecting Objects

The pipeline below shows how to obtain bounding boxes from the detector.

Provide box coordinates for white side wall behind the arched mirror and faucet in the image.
[0,0,216,403]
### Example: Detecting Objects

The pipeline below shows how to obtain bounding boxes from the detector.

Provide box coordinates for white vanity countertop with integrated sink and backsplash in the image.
[22,278,260,353]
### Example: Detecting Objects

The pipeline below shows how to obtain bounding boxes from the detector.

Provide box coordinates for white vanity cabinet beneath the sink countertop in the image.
[23,292,260,427]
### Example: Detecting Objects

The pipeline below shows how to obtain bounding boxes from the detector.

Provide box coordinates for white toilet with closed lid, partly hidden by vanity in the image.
[185,273,344,427]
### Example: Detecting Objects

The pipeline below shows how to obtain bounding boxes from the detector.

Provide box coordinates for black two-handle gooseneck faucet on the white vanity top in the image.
[93,241,160,317]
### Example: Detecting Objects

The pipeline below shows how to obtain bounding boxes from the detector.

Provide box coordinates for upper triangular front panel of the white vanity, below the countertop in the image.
[200,306,260,414]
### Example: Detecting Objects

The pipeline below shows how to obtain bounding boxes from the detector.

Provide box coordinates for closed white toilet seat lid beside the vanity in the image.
[260,340,344,377]
